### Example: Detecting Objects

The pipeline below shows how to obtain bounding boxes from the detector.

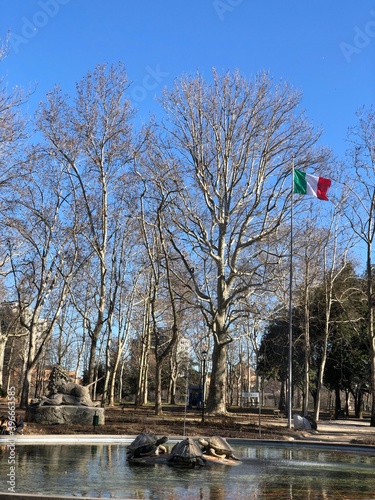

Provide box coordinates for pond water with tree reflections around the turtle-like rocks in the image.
[0,442,375,500]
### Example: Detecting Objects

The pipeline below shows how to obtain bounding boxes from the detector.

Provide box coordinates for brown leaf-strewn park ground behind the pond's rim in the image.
[0,400,375,446]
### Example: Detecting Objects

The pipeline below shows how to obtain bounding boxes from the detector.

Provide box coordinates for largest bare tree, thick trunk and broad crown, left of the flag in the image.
[154,71,328,414]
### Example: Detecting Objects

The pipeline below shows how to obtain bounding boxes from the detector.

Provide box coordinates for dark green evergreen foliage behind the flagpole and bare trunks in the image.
[257,263,371,402]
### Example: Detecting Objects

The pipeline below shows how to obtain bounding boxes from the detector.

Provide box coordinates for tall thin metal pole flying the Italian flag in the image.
[287,156,294,429]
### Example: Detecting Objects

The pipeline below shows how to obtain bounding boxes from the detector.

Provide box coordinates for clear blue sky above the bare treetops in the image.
[0,0,375,158]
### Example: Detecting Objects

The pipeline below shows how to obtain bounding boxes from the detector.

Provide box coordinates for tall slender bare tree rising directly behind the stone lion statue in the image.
[38,65,141,390]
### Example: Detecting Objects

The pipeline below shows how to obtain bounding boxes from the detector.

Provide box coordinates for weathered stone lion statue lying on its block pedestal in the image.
[39,365,97,406]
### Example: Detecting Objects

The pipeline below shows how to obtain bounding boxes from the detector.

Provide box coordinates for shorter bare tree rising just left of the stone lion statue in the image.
[2,153,77,407]
